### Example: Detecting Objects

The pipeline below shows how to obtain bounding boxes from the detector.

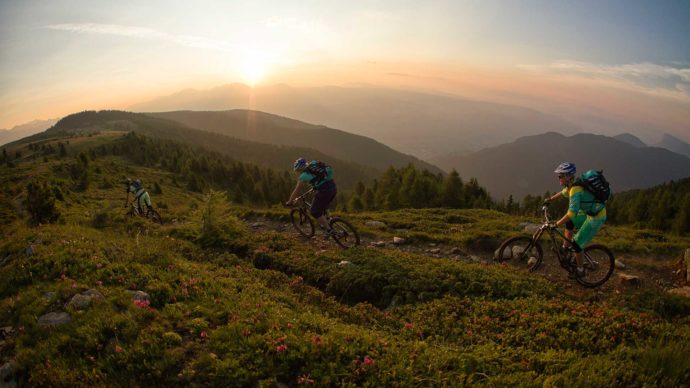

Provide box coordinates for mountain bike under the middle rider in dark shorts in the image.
[290,189,359,249]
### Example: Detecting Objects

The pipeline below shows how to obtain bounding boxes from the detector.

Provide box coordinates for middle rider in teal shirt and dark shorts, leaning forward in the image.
[286,158,338,236]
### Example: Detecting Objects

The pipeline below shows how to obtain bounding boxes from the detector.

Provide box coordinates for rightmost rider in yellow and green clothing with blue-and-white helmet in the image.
[544,162,606,277]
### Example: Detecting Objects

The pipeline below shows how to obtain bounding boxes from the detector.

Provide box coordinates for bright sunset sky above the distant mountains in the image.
[0,0,690,141]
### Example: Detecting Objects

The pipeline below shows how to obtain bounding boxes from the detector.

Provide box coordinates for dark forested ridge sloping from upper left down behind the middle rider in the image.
[19,111,380,189]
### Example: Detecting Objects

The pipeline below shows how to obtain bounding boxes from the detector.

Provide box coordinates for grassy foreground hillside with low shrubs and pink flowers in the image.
[0,128,690,386]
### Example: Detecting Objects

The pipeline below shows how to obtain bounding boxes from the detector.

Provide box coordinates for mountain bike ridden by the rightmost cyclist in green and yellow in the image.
[494,205,616,288]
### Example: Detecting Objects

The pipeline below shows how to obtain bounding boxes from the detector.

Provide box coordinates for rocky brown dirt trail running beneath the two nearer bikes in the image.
[245,217,681,299]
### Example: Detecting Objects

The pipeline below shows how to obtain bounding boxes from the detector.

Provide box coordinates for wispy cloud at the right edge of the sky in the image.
[518,61,690,100]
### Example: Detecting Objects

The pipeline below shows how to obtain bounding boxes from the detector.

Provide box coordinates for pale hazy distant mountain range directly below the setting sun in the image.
[131,84,579,160]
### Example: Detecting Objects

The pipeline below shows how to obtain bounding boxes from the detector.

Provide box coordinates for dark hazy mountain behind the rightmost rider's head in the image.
[432,132,690,198]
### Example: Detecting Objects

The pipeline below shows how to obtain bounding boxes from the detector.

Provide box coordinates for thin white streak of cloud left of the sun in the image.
[42,23,239,51]
